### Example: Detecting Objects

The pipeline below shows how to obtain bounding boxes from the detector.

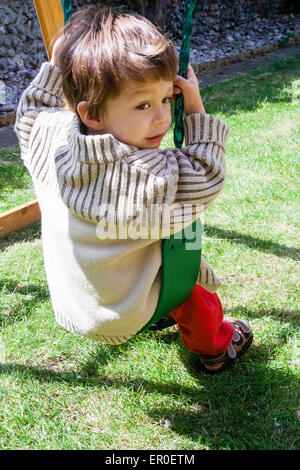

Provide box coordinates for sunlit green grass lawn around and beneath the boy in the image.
[0,56,300,450]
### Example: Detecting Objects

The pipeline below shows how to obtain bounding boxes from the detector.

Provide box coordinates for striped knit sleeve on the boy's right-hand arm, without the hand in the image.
[117,114,229,238]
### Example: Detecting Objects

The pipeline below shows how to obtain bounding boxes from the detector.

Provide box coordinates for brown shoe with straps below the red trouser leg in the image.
[196,318,253,374]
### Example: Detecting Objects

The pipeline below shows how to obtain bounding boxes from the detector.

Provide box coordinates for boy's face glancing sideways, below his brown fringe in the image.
[97,80,173,149]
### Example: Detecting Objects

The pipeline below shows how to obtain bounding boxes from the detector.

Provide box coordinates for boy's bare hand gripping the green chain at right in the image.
[174,64,205,116]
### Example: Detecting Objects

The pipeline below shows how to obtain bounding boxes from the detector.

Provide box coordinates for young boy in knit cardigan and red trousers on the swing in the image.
[15,7,252,373]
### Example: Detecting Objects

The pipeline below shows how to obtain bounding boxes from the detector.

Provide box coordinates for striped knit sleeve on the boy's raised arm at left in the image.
[14,62,63,164]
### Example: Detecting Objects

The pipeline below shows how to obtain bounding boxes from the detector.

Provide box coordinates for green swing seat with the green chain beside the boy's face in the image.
[141,0,202,331]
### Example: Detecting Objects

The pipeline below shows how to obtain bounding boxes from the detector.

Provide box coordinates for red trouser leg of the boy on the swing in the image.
[171,285,233,355]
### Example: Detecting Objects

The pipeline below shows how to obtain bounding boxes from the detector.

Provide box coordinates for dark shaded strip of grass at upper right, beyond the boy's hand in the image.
[199,54,300,116]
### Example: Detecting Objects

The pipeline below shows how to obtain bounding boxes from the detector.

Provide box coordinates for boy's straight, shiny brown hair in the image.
[60,6,178,117]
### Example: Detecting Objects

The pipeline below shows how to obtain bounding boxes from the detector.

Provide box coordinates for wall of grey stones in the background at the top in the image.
[0,0,300,112]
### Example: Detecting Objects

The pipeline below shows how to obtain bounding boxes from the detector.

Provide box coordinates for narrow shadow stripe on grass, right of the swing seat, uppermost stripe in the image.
[204,225,300,260]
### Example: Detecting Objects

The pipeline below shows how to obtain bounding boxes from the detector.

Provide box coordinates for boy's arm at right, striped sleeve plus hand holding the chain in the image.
[128,66,229,236]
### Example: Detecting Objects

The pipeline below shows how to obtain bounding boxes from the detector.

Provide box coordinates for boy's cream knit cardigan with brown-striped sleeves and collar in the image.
[15,62,228,344]
